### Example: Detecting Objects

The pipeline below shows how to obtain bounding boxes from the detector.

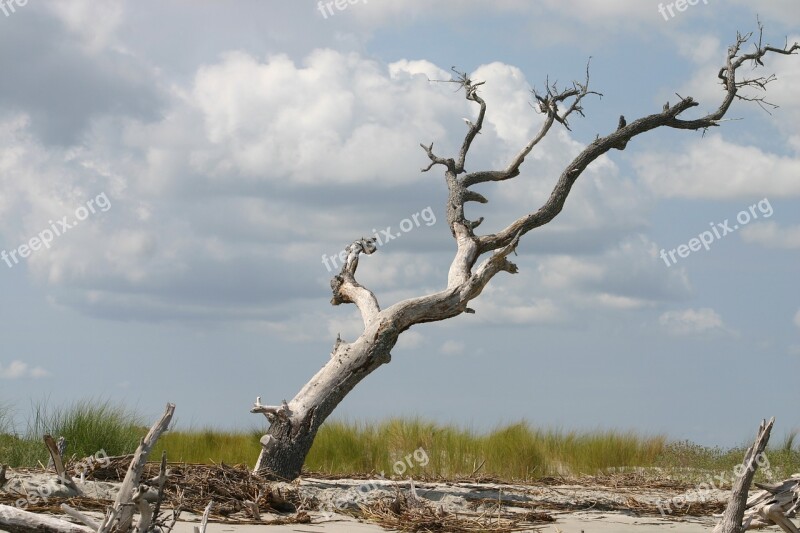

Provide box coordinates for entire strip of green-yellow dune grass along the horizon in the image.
[0,401,800,481]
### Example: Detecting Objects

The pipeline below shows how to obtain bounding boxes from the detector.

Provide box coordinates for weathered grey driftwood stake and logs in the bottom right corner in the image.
[714,418,800,533]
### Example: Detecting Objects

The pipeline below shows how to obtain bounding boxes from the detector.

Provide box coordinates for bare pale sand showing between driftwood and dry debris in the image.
[0,473,788,533]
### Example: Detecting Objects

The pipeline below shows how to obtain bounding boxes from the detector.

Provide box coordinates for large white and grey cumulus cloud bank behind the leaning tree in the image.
[0,44,673,328]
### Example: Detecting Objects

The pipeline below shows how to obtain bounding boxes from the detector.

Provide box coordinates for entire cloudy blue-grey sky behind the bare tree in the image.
[0,0,800,446]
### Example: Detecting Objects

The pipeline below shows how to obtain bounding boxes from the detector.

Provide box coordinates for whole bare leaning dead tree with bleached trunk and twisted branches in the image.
[251,28,800,479]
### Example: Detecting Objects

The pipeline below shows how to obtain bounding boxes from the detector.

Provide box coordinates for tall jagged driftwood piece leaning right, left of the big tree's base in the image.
[98,403,175,533]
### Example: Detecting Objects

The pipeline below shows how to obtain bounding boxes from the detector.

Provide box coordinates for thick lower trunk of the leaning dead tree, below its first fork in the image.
[253,320,399,480]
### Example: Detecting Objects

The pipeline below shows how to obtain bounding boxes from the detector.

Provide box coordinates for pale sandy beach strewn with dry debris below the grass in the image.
[0,471,756,533]
